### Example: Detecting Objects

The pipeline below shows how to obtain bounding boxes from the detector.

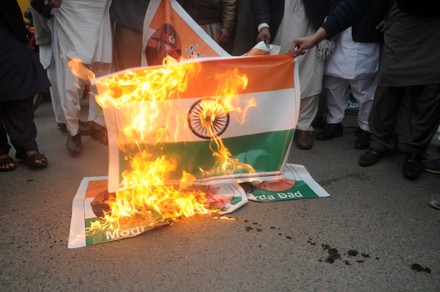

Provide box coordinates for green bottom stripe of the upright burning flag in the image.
[119,129,294,180]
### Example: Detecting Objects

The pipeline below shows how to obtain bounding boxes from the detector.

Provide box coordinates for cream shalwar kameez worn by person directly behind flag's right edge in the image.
[274,0,324,131]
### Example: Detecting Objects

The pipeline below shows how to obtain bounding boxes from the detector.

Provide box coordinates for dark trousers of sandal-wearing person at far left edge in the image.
[0,97,38,154]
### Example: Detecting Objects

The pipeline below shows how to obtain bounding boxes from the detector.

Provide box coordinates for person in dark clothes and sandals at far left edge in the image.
[0,0,54,172]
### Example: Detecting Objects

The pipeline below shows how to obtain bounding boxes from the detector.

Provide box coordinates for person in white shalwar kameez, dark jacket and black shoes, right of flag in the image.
[316,0,392,149]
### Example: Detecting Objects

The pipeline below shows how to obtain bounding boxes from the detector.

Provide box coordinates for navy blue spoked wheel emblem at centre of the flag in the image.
[187,98,230,139]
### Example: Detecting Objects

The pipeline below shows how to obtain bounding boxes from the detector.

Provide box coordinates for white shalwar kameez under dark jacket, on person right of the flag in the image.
[324,27,380,132]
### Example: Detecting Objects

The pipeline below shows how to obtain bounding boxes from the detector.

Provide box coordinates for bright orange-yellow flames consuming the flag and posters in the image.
[70,58,256,232]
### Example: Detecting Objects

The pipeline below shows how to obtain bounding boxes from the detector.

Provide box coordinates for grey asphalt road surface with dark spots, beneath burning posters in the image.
[0,102,440,291]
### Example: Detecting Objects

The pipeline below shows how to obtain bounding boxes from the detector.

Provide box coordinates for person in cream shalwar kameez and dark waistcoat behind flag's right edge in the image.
[252,0,327,150]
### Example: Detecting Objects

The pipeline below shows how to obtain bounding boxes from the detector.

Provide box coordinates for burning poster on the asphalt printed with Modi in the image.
[68,176,248,248]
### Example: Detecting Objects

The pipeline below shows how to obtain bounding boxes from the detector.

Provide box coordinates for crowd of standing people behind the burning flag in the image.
[0,0,440,205]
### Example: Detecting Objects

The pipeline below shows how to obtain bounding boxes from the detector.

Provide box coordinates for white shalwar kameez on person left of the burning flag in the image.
[52,0,112,136]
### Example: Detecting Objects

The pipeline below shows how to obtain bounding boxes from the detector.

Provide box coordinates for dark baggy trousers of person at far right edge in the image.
[369,84,440,154]
